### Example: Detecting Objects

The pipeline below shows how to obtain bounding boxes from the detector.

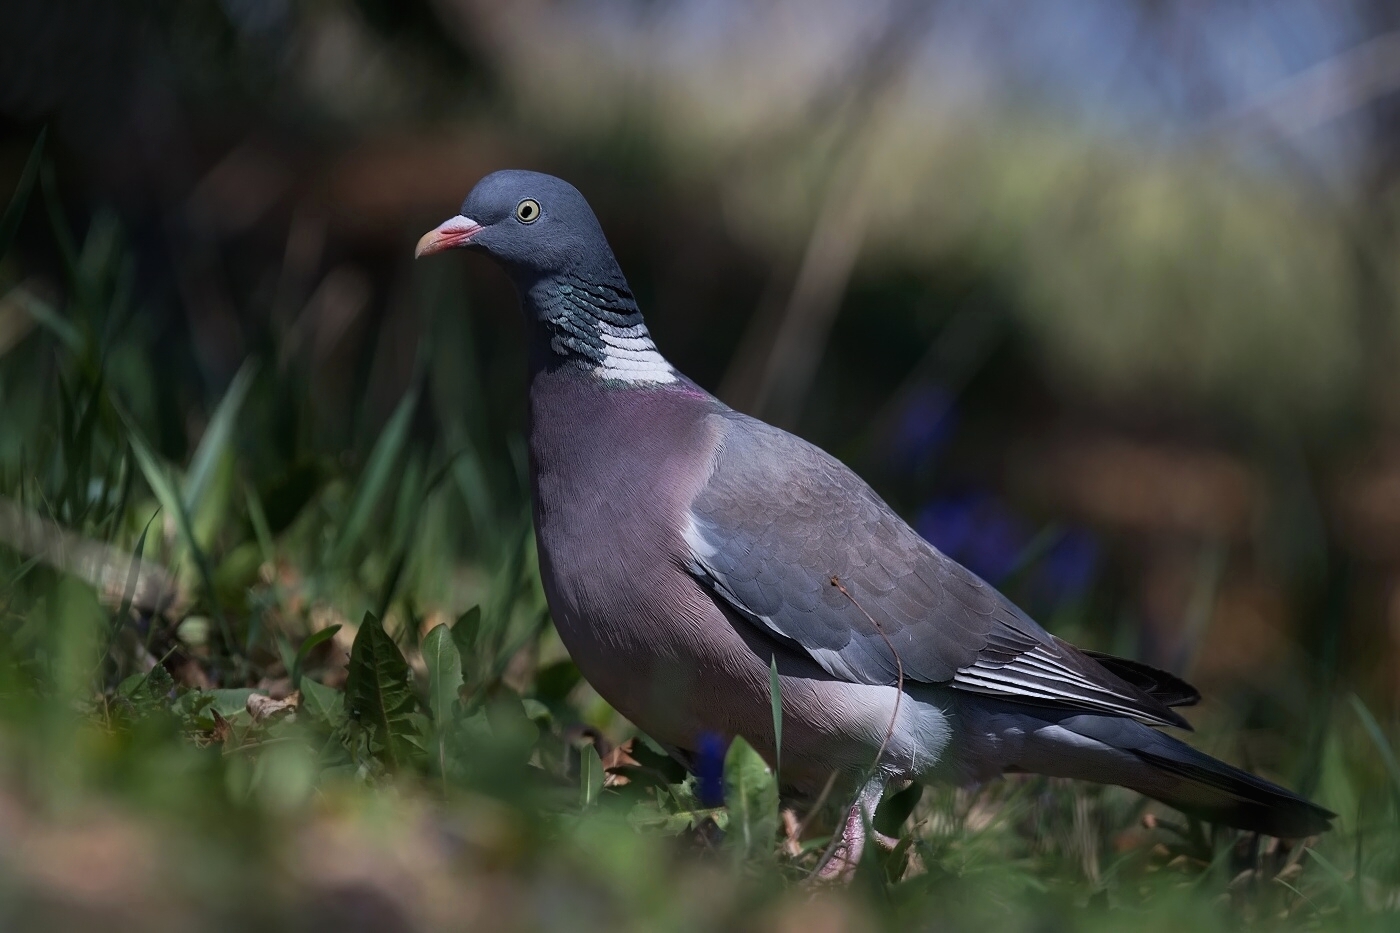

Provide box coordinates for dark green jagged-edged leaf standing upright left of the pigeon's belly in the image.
[346,612,417,768]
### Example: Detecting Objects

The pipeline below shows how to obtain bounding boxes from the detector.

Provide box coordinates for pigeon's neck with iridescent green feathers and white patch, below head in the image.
[525,276,676,384]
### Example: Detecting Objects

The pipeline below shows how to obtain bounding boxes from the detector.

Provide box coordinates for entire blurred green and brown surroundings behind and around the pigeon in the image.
[0,0,1400,930]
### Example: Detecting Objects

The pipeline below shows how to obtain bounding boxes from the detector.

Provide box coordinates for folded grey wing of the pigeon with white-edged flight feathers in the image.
[686,412,1190,728]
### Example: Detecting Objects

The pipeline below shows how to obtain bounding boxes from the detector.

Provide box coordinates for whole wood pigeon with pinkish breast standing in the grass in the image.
[417,171,1333,870]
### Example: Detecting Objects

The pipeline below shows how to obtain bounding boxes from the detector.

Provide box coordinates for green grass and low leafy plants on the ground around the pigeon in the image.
[0,140,1400,932]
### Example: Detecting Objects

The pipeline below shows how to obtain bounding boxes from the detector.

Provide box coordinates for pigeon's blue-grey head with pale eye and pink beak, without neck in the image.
[416,170,617,281]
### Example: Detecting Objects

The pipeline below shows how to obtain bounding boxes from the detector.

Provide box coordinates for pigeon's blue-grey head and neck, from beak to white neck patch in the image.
[416,171,678,384]
